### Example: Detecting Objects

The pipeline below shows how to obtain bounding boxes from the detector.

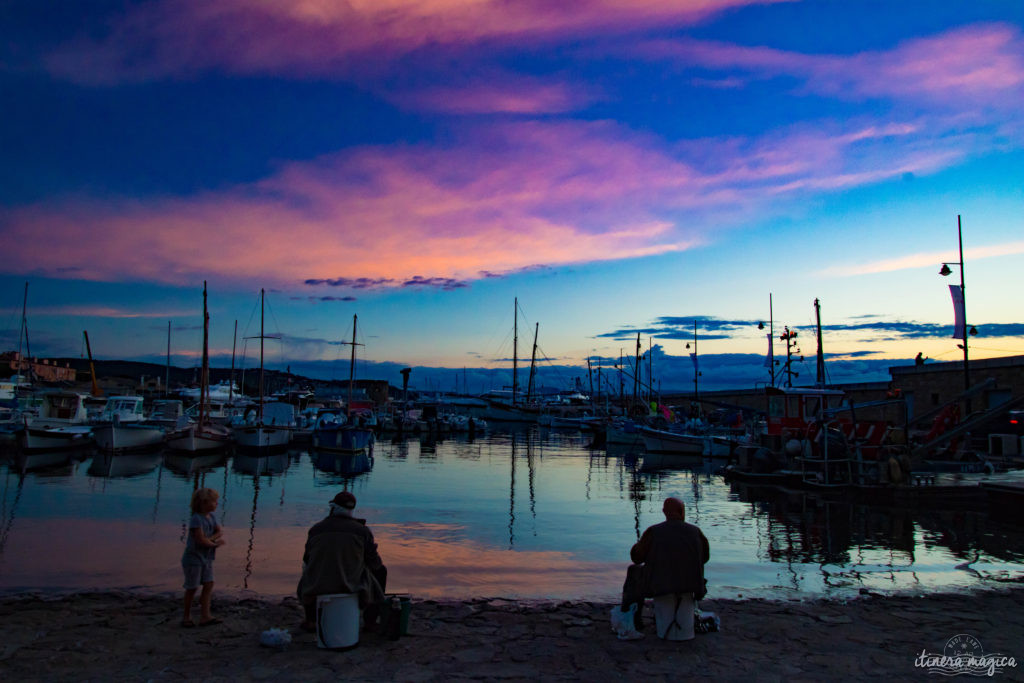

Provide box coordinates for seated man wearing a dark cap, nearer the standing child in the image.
[298,492,387,631]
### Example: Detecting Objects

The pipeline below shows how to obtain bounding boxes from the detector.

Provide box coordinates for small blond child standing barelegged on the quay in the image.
[181,488,224,628]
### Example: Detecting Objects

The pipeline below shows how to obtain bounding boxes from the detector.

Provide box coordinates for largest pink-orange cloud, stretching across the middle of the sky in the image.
[0,116,991,286]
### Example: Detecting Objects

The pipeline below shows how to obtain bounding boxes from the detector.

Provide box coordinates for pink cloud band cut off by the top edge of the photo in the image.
[47,0,786,84]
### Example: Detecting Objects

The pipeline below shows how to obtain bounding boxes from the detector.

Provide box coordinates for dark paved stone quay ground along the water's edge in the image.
[0,589,1024,681]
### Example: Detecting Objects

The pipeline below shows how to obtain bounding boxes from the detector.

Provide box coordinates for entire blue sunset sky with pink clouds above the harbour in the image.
[0,0,1024,391]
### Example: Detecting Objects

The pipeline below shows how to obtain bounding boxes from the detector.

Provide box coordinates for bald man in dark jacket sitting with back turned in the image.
[622,498,711,630]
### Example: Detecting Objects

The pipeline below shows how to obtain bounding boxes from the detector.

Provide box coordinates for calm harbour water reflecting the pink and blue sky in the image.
[0,429,1024,600]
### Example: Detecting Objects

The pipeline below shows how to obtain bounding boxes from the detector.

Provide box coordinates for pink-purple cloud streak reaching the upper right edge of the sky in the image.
[637,24,1024,109]
